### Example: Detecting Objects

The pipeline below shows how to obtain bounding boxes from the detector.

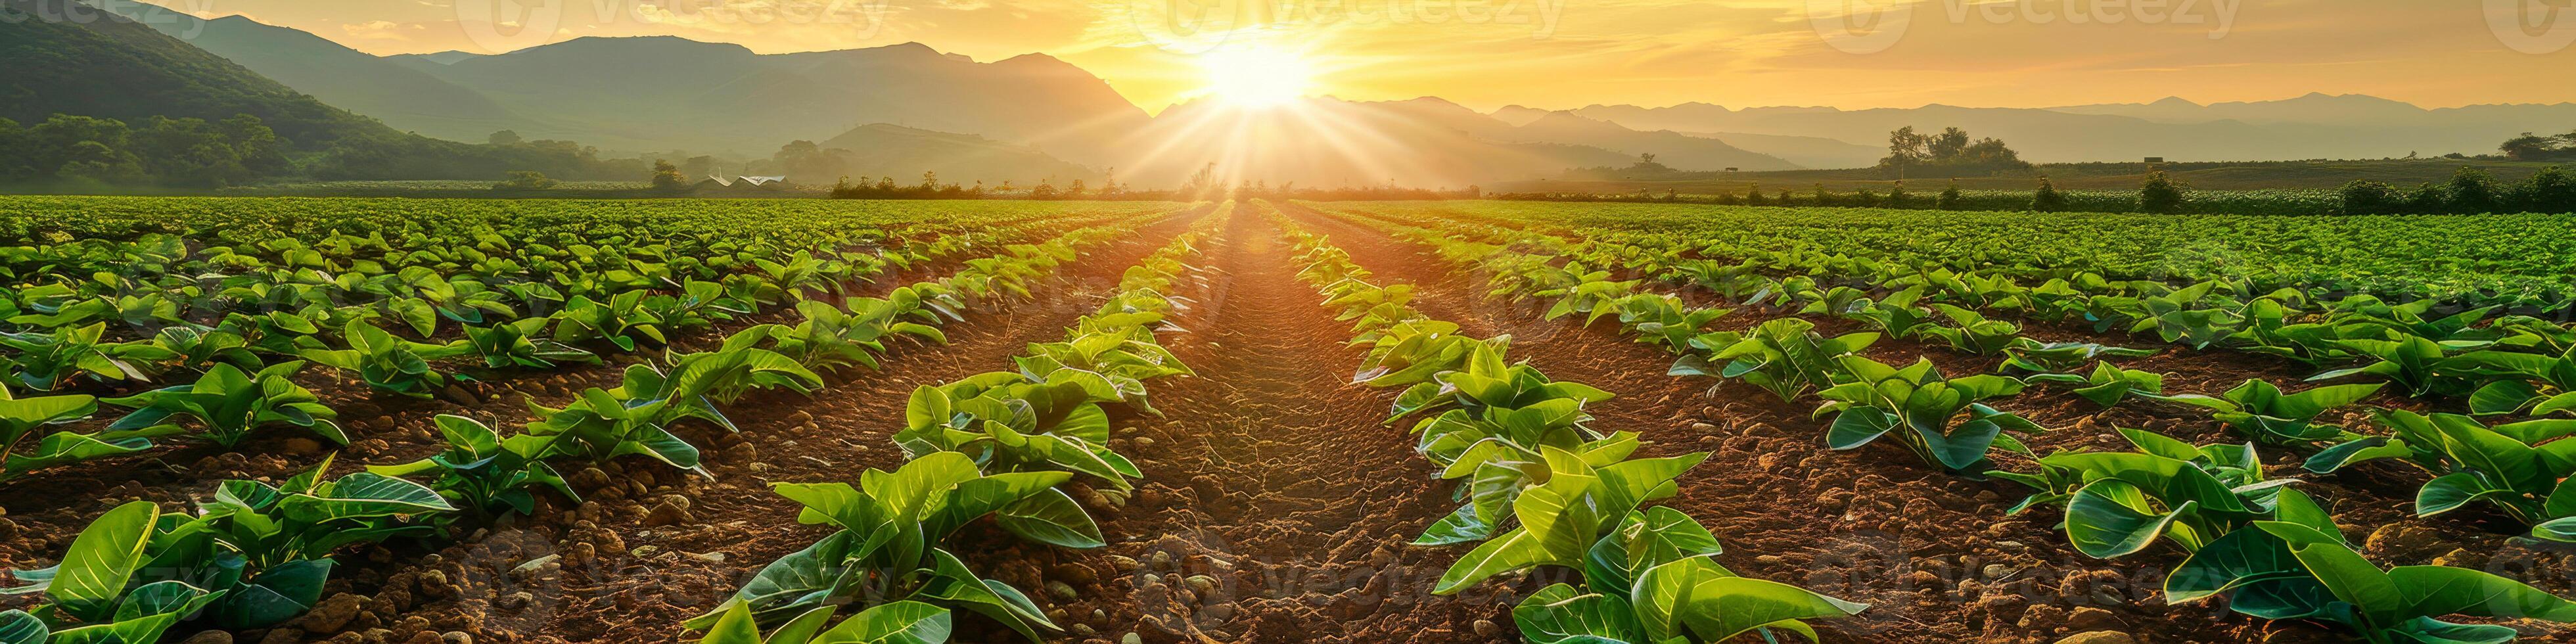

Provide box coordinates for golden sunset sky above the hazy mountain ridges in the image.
[154,0,2576,111]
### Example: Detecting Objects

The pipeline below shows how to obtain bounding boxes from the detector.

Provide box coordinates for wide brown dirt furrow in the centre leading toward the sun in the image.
[1040,216,1509,641]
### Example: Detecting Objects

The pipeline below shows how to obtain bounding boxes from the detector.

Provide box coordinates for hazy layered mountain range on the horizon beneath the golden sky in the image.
[20,0,2576,185]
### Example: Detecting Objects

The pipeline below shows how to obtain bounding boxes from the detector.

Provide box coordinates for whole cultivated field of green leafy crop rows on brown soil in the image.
[0,198,2576,644]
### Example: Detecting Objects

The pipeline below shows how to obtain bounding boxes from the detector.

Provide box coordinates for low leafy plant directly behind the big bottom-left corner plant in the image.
[106,361,348,448]
